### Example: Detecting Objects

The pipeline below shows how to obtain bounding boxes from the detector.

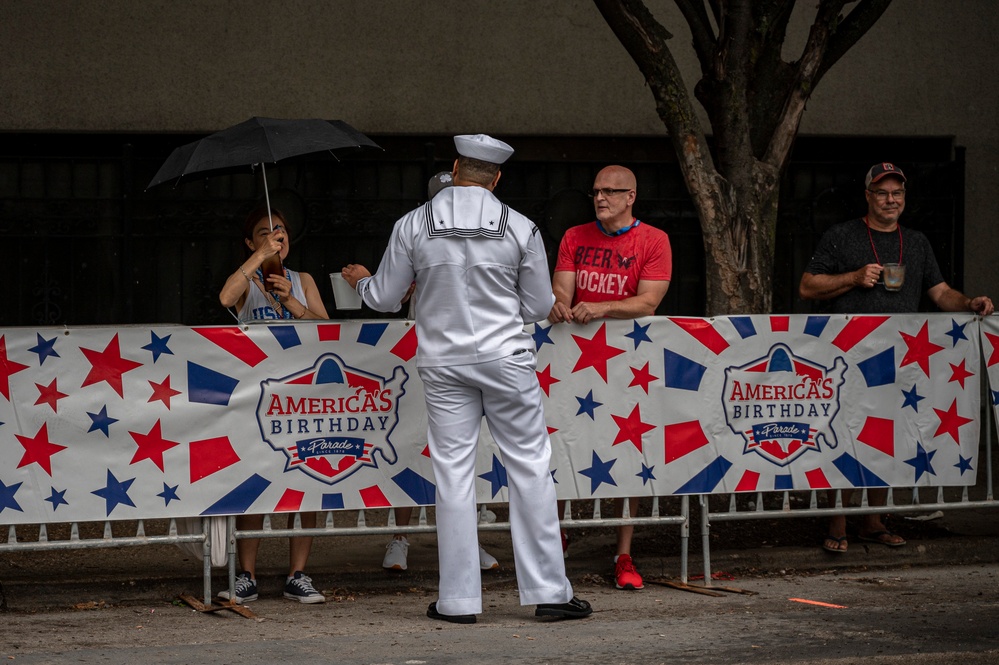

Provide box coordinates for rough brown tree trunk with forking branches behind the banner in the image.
[594,0,891,316]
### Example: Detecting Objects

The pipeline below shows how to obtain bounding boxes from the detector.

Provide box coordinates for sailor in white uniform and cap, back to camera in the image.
[342,134,592,623]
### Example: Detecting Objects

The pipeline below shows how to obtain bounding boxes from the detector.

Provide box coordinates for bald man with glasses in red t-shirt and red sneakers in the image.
[548,166,673,590]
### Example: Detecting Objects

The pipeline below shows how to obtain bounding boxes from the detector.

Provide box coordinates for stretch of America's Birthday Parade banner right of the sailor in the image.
[534,314,980,498]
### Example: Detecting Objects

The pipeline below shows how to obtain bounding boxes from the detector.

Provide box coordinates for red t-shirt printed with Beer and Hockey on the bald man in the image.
[555,222,673,305]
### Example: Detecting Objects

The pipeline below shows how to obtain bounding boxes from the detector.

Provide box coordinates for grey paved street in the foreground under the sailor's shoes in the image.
[0,536,999,665]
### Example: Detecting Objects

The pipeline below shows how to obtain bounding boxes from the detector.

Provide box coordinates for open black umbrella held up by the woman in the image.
[146,118,381,230]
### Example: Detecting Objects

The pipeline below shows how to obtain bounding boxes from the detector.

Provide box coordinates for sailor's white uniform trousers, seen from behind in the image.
[419,350,573,615]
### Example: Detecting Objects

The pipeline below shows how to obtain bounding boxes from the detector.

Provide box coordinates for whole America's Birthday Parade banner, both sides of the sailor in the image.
[0,315,997,524]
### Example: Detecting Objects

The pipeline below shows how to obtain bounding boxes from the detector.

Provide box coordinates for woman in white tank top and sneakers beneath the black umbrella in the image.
[219,206,329,604]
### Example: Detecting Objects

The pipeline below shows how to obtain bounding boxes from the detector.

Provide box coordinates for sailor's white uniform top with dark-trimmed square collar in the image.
[357,187,555,367]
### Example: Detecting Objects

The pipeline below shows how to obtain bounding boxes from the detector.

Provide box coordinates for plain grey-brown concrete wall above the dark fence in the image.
[0,0,999,297]
